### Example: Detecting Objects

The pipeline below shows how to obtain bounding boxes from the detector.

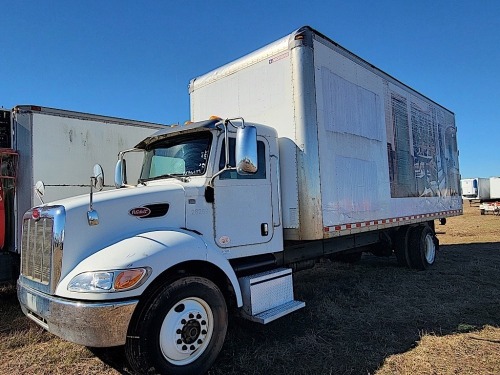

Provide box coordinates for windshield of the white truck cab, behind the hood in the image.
[139,132,212,181]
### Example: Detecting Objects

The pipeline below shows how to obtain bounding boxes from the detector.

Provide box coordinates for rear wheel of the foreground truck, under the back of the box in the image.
[409,225,439,270]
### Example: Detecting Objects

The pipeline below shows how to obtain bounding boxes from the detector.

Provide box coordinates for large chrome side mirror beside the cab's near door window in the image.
[236,125,257,175]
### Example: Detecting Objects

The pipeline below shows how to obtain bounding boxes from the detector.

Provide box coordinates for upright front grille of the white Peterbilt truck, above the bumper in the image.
[21,218,54,285]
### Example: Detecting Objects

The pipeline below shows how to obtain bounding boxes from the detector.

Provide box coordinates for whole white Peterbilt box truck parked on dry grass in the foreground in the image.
[18,27,462,374]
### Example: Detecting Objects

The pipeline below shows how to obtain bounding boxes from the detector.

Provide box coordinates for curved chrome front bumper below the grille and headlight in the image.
[17,279,139,347]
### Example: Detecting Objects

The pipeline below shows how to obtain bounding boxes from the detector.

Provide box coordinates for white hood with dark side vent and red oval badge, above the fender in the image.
[50,183,186,277]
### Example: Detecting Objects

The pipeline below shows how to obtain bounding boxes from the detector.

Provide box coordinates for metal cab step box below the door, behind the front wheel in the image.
[238,268,306,324]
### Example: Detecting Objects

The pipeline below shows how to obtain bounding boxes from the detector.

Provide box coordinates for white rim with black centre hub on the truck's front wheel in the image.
[160,297,214,366]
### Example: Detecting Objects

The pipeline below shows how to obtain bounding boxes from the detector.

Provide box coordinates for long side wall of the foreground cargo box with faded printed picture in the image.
[314,40,461,232]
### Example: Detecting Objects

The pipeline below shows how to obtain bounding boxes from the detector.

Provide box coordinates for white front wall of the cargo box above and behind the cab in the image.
[190,49,298,228]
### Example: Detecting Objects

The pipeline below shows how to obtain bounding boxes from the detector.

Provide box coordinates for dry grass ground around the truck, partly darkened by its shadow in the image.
[0,206,500,375]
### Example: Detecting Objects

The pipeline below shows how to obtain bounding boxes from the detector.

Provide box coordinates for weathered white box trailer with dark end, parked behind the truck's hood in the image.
[0,105,161,281]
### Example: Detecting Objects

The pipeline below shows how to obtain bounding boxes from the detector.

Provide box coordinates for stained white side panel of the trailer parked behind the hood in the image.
[30,113,154,203]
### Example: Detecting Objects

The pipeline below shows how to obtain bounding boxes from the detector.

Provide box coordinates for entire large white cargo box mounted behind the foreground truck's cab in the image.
[190,27,462,240]
